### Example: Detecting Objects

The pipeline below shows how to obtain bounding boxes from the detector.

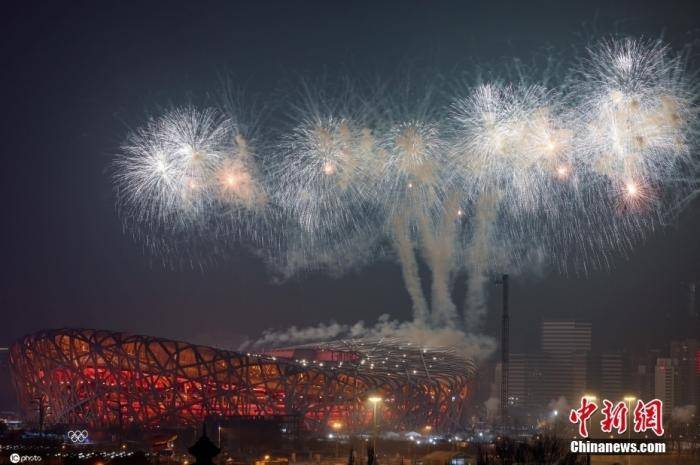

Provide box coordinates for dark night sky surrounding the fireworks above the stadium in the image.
[0,0,700,358]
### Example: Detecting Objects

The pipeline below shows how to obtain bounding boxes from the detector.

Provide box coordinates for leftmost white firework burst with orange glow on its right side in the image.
[114,107,267,248]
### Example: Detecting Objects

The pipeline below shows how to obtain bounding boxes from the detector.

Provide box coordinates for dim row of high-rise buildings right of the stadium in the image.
[490,319,700,418]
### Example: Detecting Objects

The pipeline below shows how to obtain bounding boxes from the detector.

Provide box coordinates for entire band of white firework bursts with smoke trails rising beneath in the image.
[114,39,699,340]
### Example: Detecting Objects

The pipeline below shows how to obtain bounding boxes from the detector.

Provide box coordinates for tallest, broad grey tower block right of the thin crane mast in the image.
[542,320,592,401]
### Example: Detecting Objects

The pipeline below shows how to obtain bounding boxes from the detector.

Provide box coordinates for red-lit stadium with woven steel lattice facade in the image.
[10,329,475,433]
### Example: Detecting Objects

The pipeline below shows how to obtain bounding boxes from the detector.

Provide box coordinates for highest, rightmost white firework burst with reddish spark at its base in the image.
[573,39,697,206]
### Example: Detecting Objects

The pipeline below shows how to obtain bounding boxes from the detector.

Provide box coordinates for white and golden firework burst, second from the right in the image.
[451,84,572,212]
